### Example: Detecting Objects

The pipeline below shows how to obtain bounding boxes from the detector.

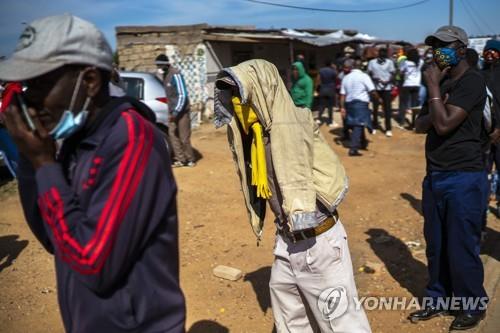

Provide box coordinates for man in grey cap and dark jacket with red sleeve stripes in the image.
[0,14,185,333]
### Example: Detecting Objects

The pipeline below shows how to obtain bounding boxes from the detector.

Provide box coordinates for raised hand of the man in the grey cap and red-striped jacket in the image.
[2,104,56,169]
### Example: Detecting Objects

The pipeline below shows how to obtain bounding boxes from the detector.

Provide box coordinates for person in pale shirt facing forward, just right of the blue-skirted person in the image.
[368,48,396,137]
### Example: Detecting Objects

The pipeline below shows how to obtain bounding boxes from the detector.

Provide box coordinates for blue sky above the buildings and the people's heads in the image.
[0,0,500,55]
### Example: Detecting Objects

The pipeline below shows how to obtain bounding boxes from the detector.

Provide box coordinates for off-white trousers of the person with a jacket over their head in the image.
[269,221,371,333]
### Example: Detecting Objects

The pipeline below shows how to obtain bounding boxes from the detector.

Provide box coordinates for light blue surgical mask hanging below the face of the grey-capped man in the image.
[49,72,90,140]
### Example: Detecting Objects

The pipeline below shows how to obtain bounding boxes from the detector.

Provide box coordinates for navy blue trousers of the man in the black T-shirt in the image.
[422,171,488,313]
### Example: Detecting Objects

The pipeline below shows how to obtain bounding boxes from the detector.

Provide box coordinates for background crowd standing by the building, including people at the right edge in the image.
[291,39,500,216]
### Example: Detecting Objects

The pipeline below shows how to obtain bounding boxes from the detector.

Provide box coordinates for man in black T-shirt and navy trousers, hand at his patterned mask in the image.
[410,26,488,330]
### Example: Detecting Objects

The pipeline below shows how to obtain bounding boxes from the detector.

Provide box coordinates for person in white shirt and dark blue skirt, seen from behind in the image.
[340,59,382,156]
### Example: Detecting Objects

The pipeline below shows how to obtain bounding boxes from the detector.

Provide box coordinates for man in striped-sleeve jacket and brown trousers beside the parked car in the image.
[155,54,196,168]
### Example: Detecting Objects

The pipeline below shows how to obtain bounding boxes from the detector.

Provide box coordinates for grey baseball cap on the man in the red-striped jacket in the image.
[0,14,113,81]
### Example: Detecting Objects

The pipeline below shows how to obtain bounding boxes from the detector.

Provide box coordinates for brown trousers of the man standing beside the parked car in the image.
[168,110,195,162]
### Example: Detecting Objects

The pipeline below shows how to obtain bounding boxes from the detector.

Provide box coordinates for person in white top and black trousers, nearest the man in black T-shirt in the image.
[398,49,424,127]
